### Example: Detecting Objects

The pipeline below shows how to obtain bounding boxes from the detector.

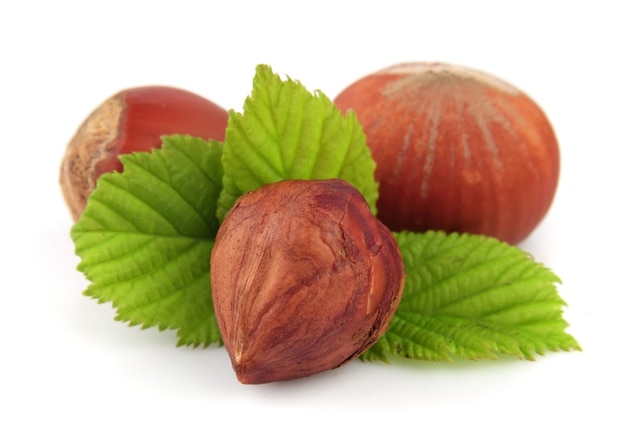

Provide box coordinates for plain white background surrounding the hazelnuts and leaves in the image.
[0,0,626,425]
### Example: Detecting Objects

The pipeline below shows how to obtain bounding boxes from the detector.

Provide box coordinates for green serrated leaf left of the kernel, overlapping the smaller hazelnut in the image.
[71,136,223,346]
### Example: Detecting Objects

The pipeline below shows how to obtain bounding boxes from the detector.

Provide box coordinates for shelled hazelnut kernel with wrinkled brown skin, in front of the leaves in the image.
[211,179,405,384]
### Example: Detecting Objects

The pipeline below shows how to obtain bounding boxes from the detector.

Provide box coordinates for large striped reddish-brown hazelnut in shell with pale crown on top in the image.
[335,63,559,244]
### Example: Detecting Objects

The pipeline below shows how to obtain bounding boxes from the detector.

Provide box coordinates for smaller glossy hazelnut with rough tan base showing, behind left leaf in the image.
[60,86,228,220]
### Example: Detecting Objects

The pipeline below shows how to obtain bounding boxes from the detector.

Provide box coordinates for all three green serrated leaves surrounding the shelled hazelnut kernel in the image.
[71,66,580,366]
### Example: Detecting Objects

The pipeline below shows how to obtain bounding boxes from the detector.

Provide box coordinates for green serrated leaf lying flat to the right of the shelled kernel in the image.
[362,232,580,361]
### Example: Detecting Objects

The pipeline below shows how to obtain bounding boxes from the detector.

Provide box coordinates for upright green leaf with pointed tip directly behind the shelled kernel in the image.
[218,65,378,219]
